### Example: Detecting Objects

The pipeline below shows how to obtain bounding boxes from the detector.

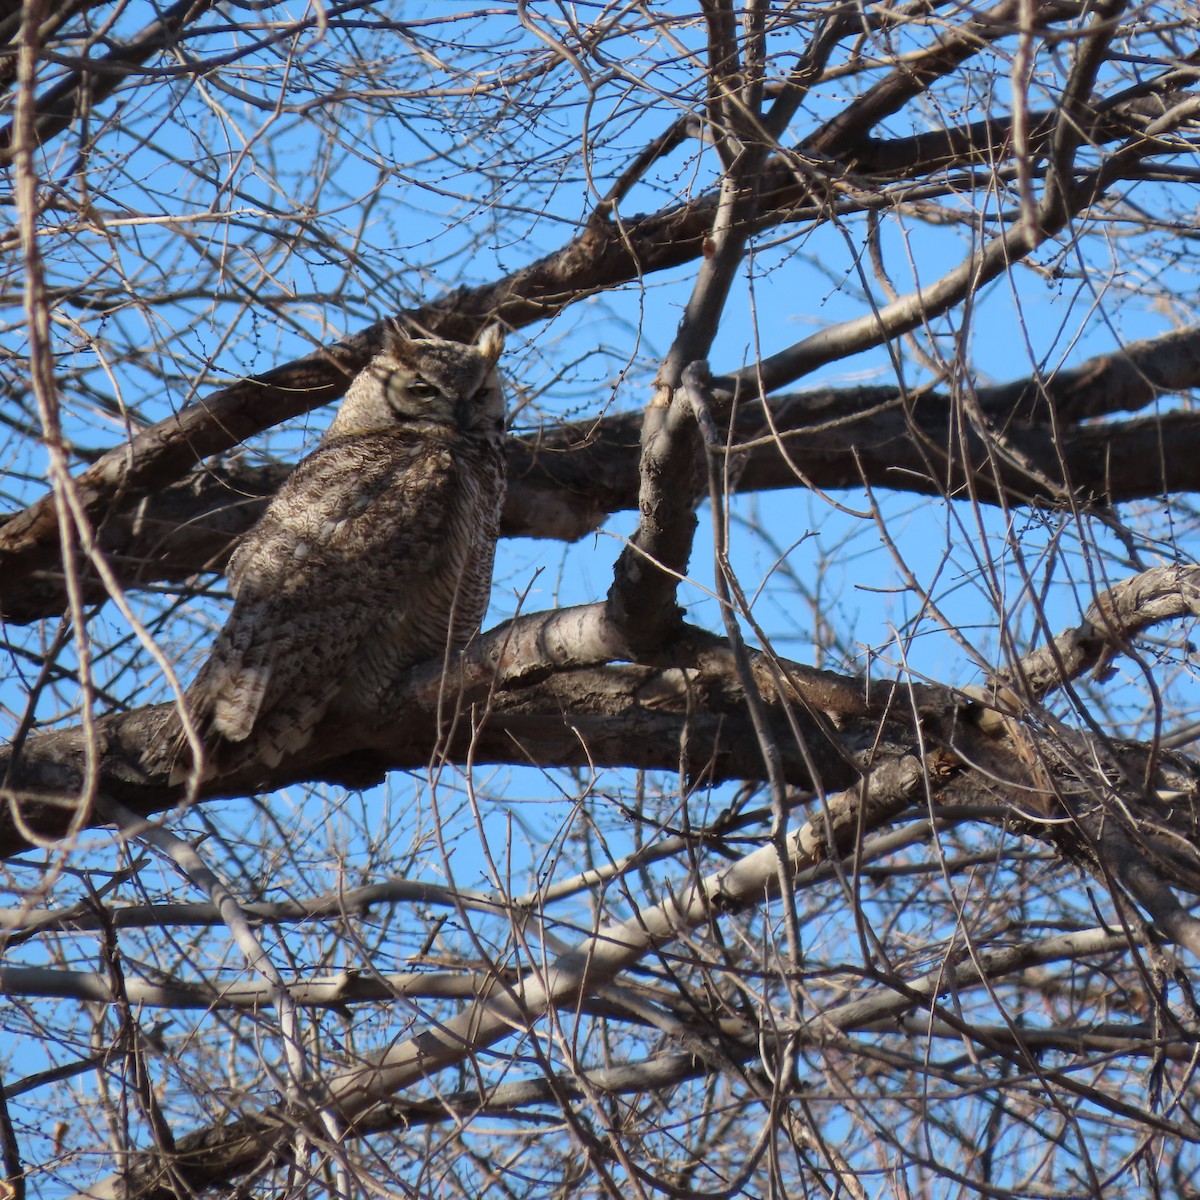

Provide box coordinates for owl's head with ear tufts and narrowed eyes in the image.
[325,325,504,439]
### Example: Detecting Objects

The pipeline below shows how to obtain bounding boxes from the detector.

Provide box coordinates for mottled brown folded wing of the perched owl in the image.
[188,433,456,766]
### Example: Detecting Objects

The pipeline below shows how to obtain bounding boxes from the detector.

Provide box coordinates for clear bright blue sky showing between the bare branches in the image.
[0,6,1198,1190]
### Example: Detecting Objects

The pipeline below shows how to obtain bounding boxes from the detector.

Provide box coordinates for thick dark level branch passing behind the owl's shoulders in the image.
[7,328,1200,624]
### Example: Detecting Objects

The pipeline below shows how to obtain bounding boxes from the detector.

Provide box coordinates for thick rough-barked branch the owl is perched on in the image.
[9,595,1200,960]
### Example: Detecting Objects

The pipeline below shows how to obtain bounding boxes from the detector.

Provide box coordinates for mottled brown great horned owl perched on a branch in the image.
[174,326,504,779]
